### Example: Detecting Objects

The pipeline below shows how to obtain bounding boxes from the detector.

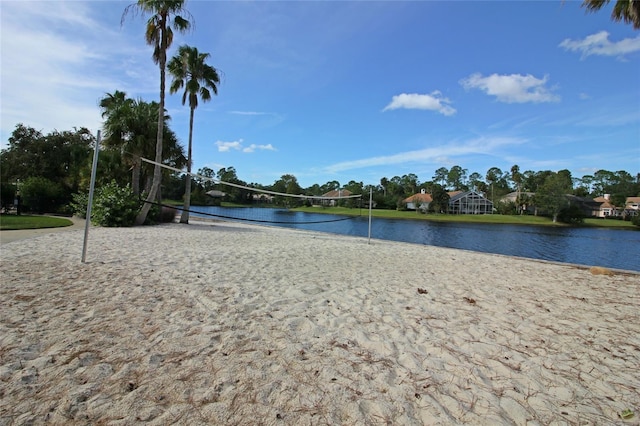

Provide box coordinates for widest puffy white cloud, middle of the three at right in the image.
[460,74,560,103]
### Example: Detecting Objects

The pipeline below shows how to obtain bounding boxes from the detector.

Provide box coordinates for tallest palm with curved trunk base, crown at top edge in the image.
[122,0,191,225]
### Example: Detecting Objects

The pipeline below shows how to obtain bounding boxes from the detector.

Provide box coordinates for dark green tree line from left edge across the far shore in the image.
[0,120,640,220]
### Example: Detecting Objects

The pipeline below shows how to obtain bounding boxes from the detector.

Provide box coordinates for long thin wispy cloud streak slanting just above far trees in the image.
[326,137,526,173]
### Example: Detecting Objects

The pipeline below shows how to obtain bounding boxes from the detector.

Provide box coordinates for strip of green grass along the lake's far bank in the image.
[293,207,640,229]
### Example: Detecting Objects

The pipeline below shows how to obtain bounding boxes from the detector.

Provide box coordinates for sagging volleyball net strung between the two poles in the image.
[141,158,368,225]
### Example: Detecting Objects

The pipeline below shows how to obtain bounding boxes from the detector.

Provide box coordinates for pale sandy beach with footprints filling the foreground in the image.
[0,222,640,425]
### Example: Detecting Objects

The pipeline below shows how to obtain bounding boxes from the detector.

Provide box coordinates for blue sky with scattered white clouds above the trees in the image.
[0,0,640,187]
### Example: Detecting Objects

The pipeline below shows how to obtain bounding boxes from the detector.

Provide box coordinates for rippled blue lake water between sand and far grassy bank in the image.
[192,207,640,272]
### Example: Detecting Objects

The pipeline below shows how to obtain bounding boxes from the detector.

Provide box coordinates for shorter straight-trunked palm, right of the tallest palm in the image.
[167,45,220,223]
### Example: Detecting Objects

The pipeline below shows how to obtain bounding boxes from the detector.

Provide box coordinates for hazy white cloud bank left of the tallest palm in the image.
[0,1,157,142]
